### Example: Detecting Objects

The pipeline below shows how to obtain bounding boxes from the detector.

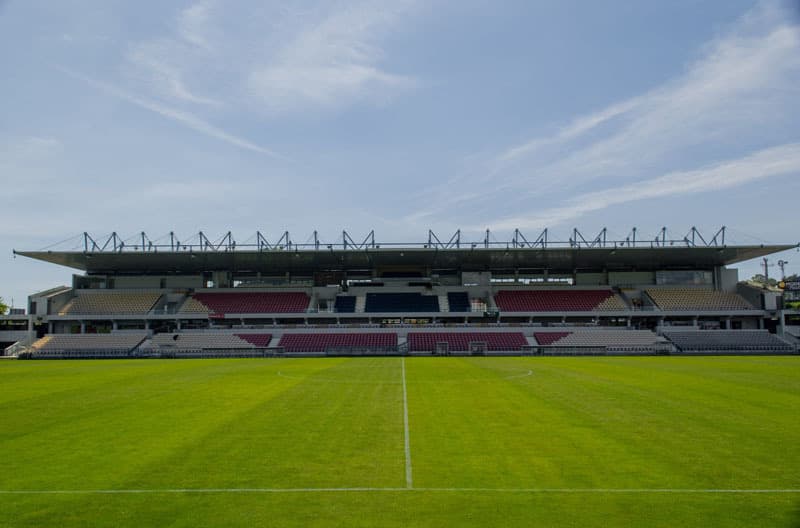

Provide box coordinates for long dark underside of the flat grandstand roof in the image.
[14,245,796,275]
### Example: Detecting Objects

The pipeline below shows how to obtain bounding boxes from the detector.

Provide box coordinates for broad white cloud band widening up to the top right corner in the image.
[409,4,800,225]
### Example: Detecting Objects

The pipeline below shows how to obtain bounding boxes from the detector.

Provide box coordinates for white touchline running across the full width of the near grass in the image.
[0,487,800,495]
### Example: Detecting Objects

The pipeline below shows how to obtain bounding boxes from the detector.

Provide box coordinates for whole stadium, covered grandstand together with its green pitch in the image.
[0,228,800,526]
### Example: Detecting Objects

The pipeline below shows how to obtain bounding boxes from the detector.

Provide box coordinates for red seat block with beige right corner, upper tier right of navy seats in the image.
[494,290,627,312]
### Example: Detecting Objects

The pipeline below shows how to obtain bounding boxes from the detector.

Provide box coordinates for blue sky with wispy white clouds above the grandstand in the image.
[0,0,800,306]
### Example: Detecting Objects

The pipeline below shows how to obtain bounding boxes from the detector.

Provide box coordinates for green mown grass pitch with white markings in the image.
[0,357,800,527]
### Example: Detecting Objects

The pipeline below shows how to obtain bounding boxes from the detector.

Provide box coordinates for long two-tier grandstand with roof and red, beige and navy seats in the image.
[0,228,800,358]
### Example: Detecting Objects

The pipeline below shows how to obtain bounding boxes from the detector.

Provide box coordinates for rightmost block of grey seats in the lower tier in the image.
[664,330,794,352]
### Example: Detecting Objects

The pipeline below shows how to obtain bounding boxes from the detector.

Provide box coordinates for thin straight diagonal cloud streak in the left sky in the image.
[58,67,286,159]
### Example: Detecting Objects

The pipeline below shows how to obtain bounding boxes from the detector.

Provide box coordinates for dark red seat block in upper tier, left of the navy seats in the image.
[194,292,310,314]
